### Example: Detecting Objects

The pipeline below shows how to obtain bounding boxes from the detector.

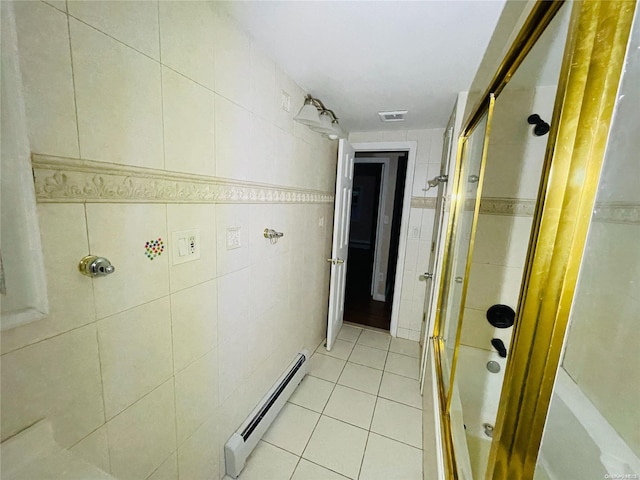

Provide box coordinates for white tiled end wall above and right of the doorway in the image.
[349,129,444,341]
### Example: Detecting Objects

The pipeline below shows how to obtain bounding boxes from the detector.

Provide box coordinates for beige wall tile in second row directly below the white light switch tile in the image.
[175,349,218,445]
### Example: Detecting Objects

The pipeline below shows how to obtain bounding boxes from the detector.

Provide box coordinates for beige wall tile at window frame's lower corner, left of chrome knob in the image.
[2,204,96,353]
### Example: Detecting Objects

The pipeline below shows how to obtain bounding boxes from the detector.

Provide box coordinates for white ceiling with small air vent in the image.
[220,0,505,132]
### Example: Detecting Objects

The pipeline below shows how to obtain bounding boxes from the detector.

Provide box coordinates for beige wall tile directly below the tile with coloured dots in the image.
[98,297,173,418]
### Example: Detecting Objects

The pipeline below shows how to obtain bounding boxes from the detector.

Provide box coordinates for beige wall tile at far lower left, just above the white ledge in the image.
[1,325,104,447]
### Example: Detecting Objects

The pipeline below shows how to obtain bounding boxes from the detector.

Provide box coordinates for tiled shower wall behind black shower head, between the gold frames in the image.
[461,87,555,350]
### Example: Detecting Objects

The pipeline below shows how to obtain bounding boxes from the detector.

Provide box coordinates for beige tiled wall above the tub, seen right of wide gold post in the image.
[560,15,640,458]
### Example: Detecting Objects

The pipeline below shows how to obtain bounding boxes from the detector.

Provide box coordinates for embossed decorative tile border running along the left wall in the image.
[32,154,334,203]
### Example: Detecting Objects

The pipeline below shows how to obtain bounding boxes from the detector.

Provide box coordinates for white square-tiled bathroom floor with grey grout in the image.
[225,325,423,480]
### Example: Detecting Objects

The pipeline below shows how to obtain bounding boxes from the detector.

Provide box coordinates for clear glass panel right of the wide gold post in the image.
[535,12,640,480]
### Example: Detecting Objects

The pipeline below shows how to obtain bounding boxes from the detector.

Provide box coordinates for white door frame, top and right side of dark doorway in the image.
[351,141,418,337]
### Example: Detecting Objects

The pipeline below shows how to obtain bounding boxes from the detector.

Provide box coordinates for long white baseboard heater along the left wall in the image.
[224,350,309,478]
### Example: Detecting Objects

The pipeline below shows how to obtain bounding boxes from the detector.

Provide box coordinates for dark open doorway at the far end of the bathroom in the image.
[344,151,409,330]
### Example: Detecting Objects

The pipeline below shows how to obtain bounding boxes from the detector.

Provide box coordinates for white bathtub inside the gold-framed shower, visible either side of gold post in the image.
[456,345,640,480]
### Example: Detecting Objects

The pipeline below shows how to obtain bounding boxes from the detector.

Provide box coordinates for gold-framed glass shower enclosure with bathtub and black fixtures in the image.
[424,1,640,480]
